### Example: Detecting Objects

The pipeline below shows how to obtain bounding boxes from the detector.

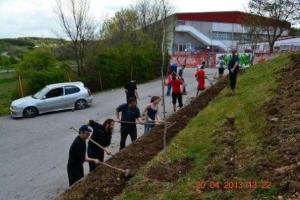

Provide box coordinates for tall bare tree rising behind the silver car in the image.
[55,0,95,76]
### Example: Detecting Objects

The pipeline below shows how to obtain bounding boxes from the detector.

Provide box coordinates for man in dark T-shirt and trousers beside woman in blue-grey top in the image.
[116,98,142,150]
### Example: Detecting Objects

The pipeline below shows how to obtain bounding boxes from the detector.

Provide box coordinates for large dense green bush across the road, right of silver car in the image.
[83,41,161,90]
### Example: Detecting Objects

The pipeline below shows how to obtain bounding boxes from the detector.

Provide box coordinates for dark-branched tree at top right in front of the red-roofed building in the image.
[249,0,300,53]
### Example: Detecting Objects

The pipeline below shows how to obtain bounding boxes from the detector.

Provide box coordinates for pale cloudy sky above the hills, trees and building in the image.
[0,0,248,38]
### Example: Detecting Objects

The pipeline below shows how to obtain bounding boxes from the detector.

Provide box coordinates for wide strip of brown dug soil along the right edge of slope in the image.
[258,55,300,199]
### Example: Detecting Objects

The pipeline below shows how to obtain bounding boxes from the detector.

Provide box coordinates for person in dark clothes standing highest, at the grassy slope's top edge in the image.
[228,50,240,94]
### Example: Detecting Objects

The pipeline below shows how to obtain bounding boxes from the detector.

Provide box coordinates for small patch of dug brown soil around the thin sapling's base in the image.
[146,159,192,182]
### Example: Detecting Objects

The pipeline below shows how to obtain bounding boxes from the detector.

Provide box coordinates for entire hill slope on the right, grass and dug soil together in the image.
[116,55,300,200]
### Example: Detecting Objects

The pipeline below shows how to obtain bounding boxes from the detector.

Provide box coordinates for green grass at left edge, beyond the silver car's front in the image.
[0,73,17,116]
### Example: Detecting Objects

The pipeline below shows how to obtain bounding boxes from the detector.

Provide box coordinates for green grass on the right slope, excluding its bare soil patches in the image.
[115,55,289,200]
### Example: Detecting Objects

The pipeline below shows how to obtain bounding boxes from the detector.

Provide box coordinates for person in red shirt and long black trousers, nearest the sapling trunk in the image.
[170,74,183,112]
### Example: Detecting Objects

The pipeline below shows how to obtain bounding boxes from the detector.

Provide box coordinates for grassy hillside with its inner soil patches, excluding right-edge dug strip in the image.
[116,55,296,200]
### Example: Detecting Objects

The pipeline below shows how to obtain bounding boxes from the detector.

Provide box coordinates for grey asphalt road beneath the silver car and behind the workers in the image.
[0,69,220,200]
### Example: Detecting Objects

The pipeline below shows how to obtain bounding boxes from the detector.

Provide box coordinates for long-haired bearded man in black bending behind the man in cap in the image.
[88,119,114,172]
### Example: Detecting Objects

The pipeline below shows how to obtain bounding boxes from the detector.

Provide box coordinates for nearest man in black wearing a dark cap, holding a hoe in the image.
[67,125,100,186]
